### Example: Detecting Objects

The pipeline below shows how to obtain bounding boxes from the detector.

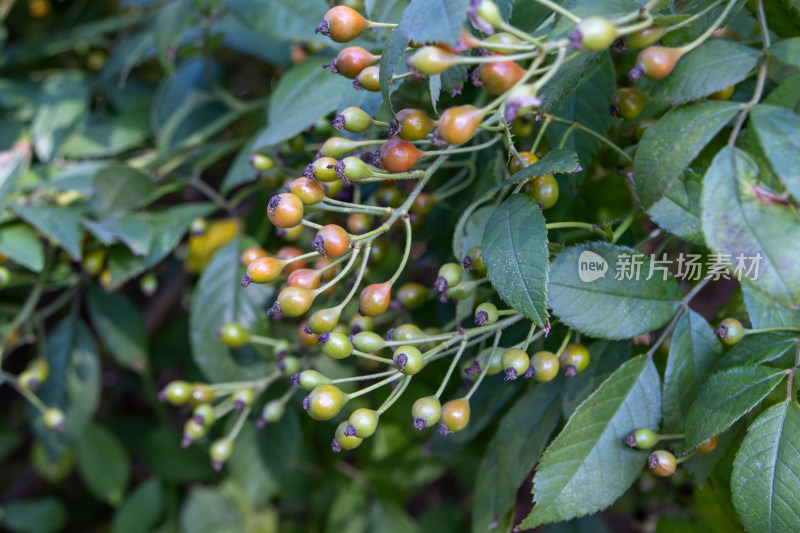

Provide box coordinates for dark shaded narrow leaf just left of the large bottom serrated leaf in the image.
[472,383,561,531]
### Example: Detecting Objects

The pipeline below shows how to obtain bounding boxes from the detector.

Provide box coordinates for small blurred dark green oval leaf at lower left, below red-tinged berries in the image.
[78,424,131,506]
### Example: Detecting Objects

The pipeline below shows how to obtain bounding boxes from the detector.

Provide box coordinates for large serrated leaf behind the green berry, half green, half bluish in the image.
[522,355,661,528]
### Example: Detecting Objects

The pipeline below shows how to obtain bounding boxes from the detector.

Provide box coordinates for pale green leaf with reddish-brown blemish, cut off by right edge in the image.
[702,147,800,308]
